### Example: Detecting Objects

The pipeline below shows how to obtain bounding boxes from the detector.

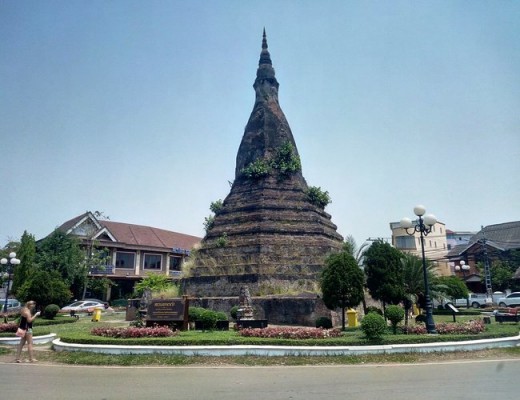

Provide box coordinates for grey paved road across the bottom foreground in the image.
[0,359,520,400]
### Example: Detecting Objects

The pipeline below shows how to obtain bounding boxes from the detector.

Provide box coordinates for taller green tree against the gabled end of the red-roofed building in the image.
[36,229,86,298]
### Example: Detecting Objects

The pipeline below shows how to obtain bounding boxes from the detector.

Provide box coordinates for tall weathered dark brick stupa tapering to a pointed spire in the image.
[186,29,343,296]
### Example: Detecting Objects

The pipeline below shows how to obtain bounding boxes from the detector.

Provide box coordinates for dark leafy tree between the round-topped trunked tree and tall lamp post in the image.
[365,240,406,306]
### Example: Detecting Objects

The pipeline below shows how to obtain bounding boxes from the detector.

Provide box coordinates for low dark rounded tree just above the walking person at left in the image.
[17,269,72,309]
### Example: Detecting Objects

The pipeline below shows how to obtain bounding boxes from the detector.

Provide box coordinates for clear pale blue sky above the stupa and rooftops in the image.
[0,0,520,247]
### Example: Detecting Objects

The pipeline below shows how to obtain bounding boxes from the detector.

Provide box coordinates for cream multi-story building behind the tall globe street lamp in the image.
[390,221,451,275]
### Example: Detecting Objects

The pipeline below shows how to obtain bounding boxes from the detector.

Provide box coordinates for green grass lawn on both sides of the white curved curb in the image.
[0,313,520,365]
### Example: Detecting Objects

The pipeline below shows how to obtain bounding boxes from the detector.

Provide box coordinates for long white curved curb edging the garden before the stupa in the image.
[52,335,520,357]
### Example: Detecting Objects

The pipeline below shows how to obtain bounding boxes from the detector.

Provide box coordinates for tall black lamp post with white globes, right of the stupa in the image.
[400,206,437,333]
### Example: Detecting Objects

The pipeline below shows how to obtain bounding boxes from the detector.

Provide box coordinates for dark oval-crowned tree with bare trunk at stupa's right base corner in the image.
[320,251,364,330]
